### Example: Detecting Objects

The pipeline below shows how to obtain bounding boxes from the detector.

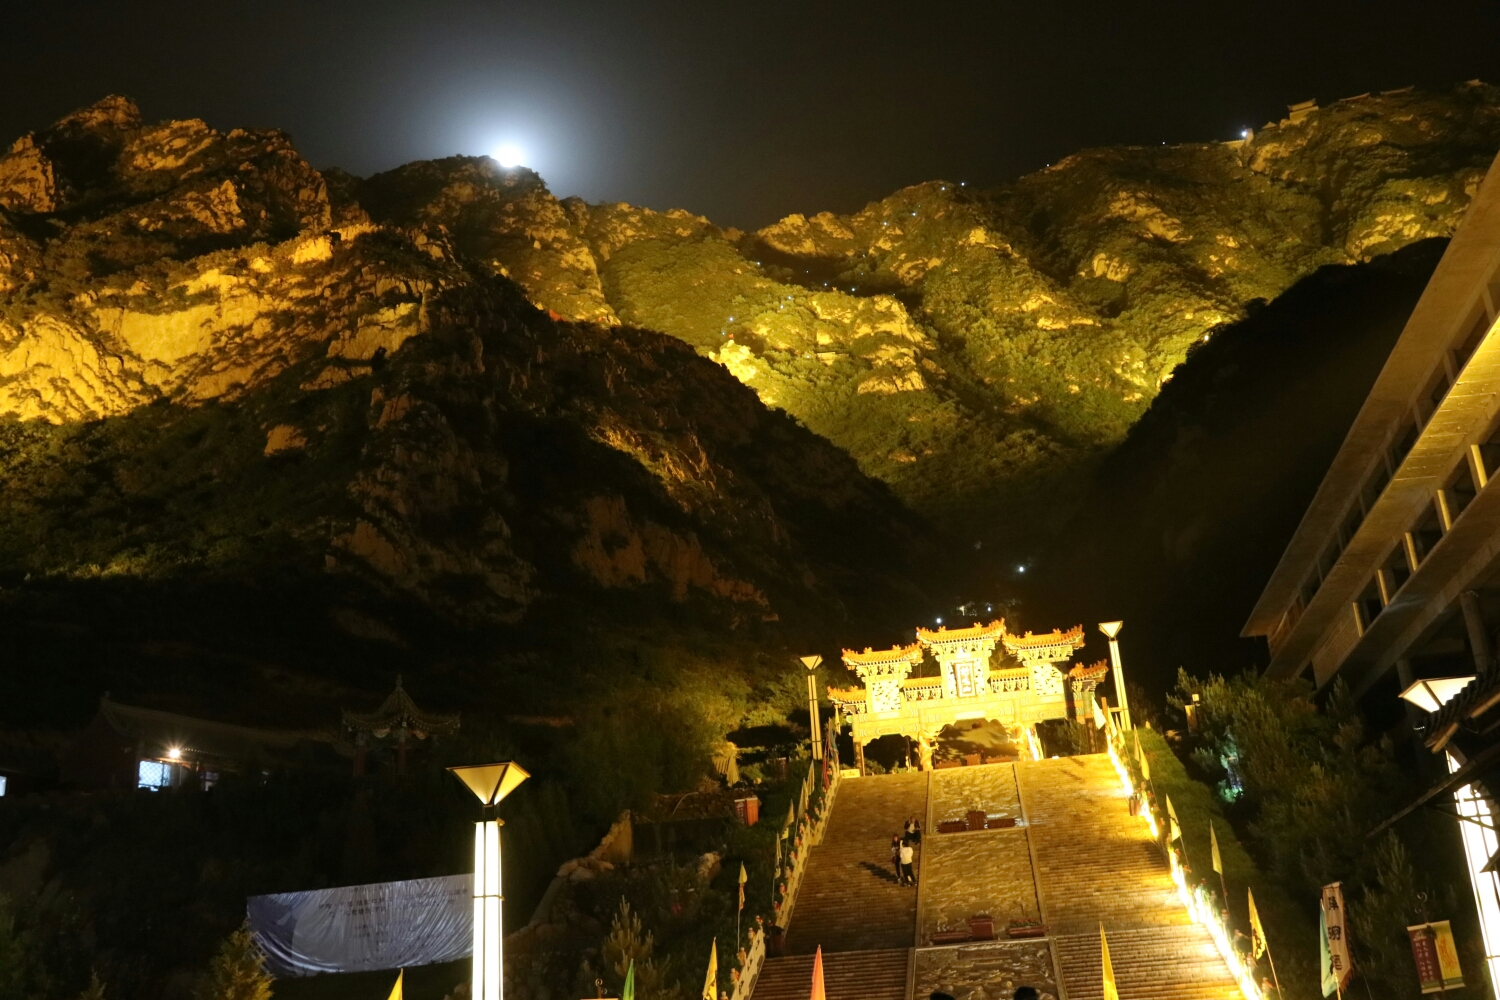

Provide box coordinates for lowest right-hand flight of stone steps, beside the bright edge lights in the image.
[1044,924,1242,1000]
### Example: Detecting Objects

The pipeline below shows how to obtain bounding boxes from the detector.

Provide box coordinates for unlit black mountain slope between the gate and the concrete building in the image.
[1031,240,1446,690]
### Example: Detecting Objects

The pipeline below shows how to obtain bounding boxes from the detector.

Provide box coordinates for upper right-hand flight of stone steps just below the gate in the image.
[1016,754,1193,936]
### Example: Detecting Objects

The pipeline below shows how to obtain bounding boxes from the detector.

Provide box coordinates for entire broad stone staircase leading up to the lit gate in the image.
[753,754,1242,1000]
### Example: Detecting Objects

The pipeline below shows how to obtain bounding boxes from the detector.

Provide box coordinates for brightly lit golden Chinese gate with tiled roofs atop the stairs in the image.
[828,619,1109,769]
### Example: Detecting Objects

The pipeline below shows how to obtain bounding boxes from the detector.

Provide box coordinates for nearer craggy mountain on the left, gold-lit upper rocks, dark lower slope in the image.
[0,97,926,728]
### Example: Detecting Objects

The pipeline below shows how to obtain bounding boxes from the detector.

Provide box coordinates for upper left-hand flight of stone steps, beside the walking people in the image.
[780,774,927,959]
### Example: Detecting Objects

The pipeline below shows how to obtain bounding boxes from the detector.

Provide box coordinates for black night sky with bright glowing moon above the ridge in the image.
[0,0,1500,226]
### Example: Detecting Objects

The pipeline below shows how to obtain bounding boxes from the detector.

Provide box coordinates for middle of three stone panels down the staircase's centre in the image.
[918,827,1041,947]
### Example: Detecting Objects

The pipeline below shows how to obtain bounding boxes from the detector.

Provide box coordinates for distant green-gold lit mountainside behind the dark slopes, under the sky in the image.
[357,84,1500,538]
